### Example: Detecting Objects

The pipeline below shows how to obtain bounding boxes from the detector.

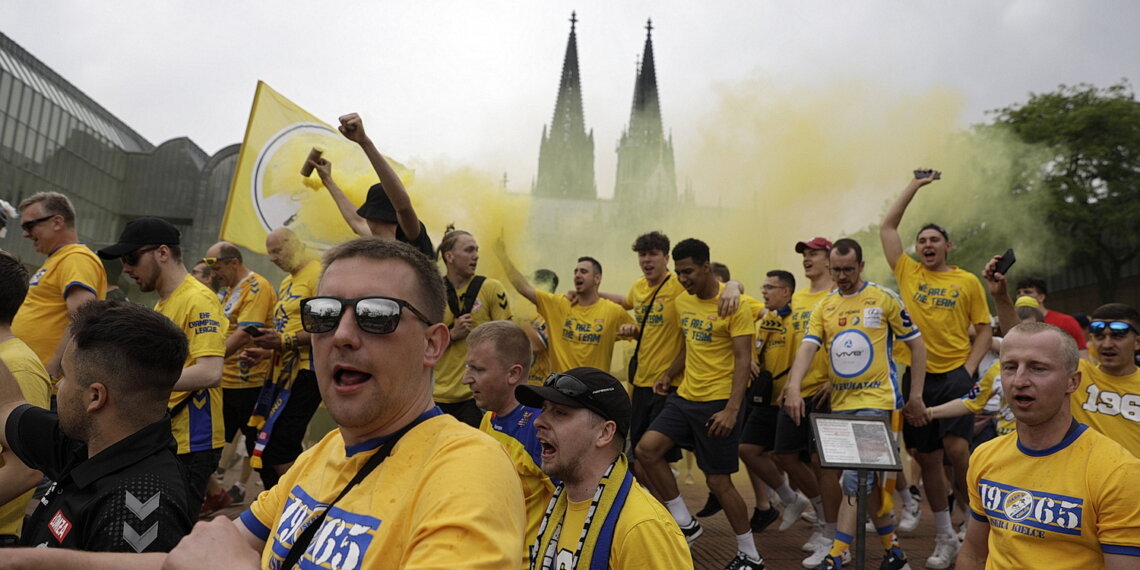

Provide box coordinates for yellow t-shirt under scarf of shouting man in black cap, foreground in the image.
[552,481,693,570]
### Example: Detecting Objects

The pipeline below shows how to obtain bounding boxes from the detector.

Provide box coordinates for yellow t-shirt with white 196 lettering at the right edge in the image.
[1072,359,1140,457]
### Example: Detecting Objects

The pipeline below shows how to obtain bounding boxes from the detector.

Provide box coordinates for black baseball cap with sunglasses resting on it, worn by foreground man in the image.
[514,367,633,438]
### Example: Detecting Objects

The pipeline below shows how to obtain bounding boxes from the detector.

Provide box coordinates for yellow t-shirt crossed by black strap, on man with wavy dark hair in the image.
[626,274,686,388]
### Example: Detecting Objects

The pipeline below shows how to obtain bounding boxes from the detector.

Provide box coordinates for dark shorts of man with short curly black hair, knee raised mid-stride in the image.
[649,393,744,475]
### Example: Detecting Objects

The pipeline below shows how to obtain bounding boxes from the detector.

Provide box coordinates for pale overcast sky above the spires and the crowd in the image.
[0,0,1140,195]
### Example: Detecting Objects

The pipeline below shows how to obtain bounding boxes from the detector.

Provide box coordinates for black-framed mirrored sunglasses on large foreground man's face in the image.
[301,296,433,334]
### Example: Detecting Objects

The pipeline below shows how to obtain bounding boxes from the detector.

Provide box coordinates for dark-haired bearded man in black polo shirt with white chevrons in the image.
[0,301,193,554]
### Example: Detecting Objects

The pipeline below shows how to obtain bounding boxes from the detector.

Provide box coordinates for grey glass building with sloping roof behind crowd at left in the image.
[0,33,283,300]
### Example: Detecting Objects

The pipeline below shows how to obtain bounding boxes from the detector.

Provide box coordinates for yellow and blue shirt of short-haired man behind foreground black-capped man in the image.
[479,405,554,567]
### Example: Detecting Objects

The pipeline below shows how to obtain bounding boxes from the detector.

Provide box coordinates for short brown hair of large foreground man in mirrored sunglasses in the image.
[321,236,446,323]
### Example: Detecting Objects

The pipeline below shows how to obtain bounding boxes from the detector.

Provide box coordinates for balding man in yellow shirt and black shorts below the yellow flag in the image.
[243,228,320,489]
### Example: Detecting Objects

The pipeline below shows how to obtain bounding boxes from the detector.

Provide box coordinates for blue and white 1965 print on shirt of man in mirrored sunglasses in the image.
[270,485,381,570]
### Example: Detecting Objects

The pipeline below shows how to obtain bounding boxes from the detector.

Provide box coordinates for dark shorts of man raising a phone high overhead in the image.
[903,366,974,454]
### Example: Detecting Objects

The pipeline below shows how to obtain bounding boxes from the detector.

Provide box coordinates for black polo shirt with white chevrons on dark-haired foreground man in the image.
[5,405,197,552]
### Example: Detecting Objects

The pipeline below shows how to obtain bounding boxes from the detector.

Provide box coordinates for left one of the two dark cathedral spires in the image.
[532,13,597,200]
